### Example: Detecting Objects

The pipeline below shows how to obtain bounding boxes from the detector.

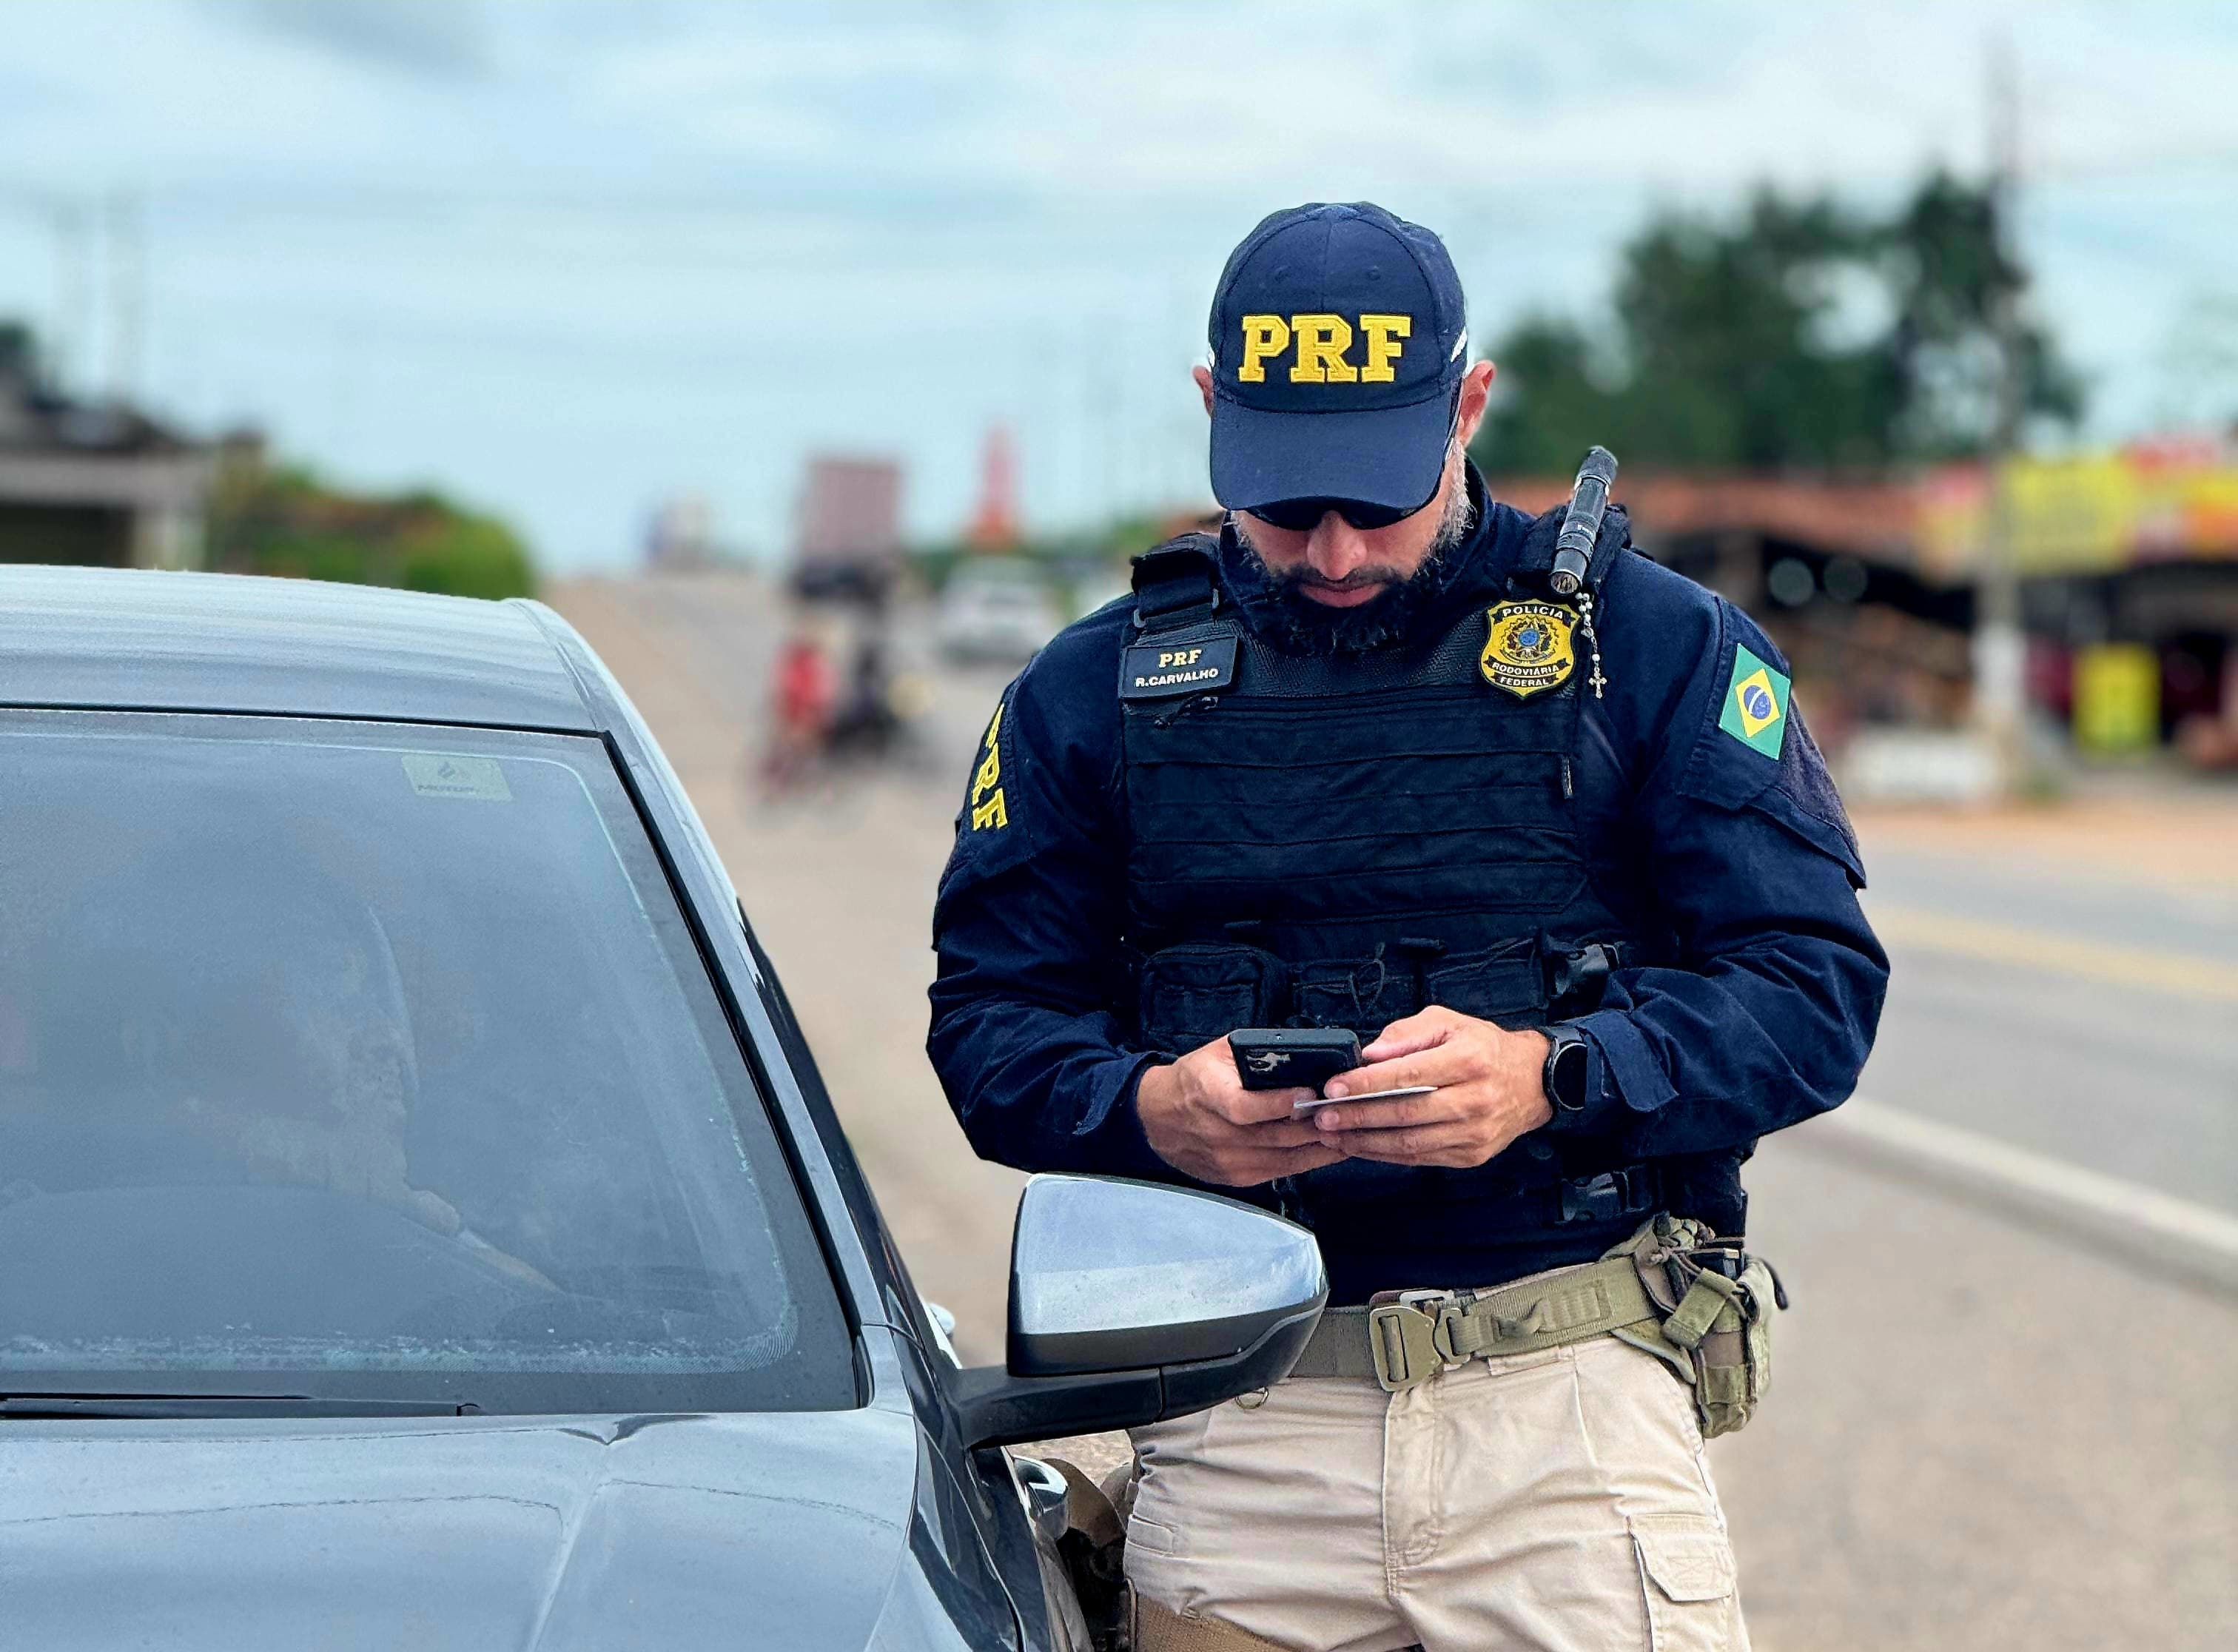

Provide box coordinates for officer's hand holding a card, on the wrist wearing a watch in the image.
[1314,1005,1553,1171]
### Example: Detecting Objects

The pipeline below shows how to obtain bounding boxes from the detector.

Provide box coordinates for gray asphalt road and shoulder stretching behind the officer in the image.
[555,575,2238,1652]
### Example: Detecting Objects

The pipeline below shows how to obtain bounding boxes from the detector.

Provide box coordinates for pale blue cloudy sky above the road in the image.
[0,0,2238,571]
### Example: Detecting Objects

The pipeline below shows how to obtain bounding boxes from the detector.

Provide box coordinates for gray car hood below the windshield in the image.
[0,1410,1014,1652]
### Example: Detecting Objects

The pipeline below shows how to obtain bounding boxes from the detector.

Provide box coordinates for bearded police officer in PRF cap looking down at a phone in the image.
[931,204,1886,1652]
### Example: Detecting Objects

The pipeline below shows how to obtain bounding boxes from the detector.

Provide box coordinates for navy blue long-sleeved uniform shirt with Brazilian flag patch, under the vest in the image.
[929,488,1886,1296]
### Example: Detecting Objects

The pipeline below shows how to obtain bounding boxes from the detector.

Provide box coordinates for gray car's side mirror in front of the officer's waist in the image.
[949,1175,1329,1446]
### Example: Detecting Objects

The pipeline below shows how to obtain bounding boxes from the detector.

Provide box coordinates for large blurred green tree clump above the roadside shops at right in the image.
[1475,172,2081,474]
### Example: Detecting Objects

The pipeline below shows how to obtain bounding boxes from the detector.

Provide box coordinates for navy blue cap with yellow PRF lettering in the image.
[1211,201,1468,511]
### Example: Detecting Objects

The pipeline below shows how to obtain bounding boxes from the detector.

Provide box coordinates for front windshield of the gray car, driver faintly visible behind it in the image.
[0,712,855,1412]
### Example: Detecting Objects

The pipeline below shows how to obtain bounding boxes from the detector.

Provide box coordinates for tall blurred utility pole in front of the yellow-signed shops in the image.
[1974,33,2028,797]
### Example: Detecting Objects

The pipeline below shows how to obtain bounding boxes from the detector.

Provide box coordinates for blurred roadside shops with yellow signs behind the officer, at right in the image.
[1493,441,2238,768]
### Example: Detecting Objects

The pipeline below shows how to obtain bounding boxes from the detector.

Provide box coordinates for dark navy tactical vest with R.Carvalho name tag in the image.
[1119,535,1739,1244]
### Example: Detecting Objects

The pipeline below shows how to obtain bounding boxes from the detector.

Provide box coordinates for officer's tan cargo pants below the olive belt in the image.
[1126,1337,1748,1652]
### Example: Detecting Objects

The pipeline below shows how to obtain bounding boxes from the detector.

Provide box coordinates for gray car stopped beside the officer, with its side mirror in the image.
[0,568,1325,1652]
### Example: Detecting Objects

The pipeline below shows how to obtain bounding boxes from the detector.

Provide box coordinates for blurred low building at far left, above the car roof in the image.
[0,329,212,568]
